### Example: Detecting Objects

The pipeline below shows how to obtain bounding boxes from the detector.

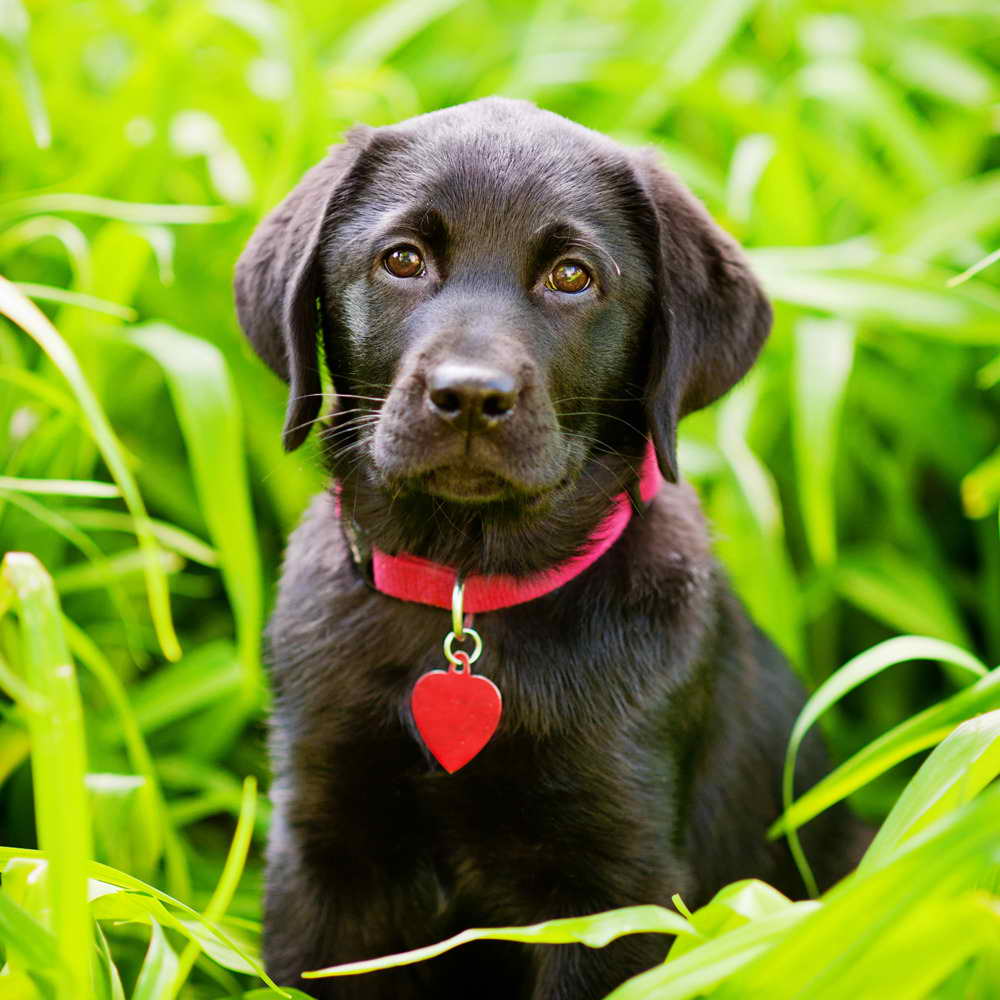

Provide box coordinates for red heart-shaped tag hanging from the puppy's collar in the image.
[410,653,503,774]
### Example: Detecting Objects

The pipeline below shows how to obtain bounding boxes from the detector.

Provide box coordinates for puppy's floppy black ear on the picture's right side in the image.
[637,154,771,482]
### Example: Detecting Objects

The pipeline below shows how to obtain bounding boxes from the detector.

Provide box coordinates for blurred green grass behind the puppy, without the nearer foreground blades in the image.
[0,0,1000,996]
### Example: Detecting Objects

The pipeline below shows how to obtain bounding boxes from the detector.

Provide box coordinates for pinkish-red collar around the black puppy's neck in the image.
[364,444,663,613]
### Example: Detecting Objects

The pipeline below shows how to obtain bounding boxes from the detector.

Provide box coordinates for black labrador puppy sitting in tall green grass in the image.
[236,99,858,1000]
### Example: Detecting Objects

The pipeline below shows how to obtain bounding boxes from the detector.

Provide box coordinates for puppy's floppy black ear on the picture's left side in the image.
[234,126,372,451]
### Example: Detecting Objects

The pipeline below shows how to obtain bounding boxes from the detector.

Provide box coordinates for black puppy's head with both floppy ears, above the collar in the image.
[236,99,771,572]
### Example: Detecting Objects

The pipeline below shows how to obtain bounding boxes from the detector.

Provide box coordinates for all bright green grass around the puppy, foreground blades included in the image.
[0,0,1000,1000]
